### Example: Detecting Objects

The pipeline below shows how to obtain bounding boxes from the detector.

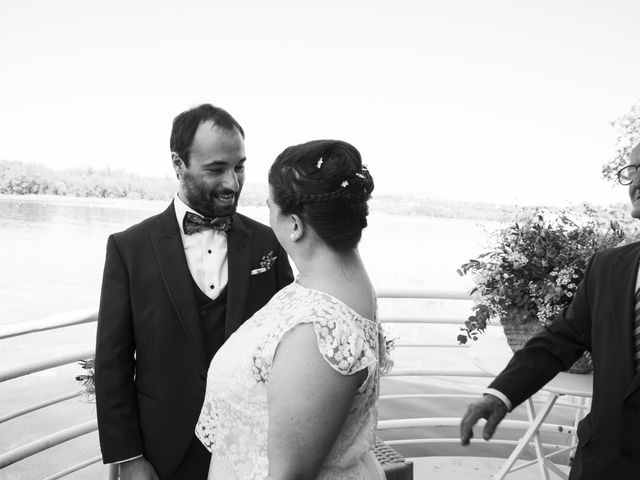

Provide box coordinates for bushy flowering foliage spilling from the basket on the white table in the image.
[457,208,637,343]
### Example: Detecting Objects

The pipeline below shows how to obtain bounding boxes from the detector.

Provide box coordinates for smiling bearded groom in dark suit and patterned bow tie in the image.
[95,104,293,480]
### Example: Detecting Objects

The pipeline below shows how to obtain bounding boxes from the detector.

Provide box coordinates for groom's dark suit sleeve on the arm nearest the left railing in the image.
[95,235,143,463]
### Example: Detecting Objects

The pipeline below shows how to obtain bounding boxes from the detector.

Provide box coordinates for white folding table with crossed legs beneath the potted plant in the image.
[469,337,593,480]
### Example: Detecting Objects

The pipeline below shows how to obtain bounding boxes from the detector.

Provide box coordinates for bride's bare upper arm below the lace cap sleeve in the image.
[267,324,367,480]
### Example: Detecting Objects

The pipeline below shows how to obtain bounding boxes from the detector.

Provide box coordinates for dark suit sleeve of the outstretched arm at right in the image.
[489,257,595,408]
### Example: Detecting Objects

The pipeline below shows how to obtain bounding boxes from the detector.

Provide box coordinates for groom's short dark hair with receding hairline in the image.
[169,103,244,166]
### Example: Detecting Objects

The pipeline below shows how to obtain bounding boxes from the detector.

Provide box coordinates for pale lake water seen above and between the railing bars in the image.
[0,196,496,480]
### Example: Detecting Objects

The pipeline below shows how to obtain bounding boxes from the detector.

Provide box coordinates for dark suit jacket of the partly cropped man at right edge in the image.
[490,242,640,480]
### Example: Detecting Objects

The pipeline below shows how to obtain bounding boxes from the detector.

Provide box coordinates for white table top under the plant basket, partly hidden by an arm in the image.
[469,337,593,397]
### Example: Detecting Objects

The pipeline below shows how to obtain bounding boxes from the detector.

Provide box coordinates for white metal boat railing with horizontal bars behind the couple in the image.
[0,289,583,480]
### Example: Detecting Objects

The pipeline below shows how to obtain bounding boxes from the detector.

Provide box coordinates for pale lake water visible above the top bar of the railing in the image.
[0,197,492,324]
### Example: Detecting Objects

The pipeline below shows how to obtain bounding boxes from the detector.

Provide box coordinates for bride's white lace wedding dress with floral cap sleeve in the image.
[196,282,391,480]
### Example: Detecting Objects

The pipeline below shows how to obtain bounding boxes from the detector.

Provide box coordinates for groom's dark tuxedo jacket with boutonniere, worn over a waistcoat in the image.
[95,203,293,478]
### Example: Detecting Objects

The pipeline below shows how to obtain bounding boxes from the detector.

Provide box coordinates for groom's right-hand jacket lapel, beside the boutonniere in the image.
[225,214,253,338]
